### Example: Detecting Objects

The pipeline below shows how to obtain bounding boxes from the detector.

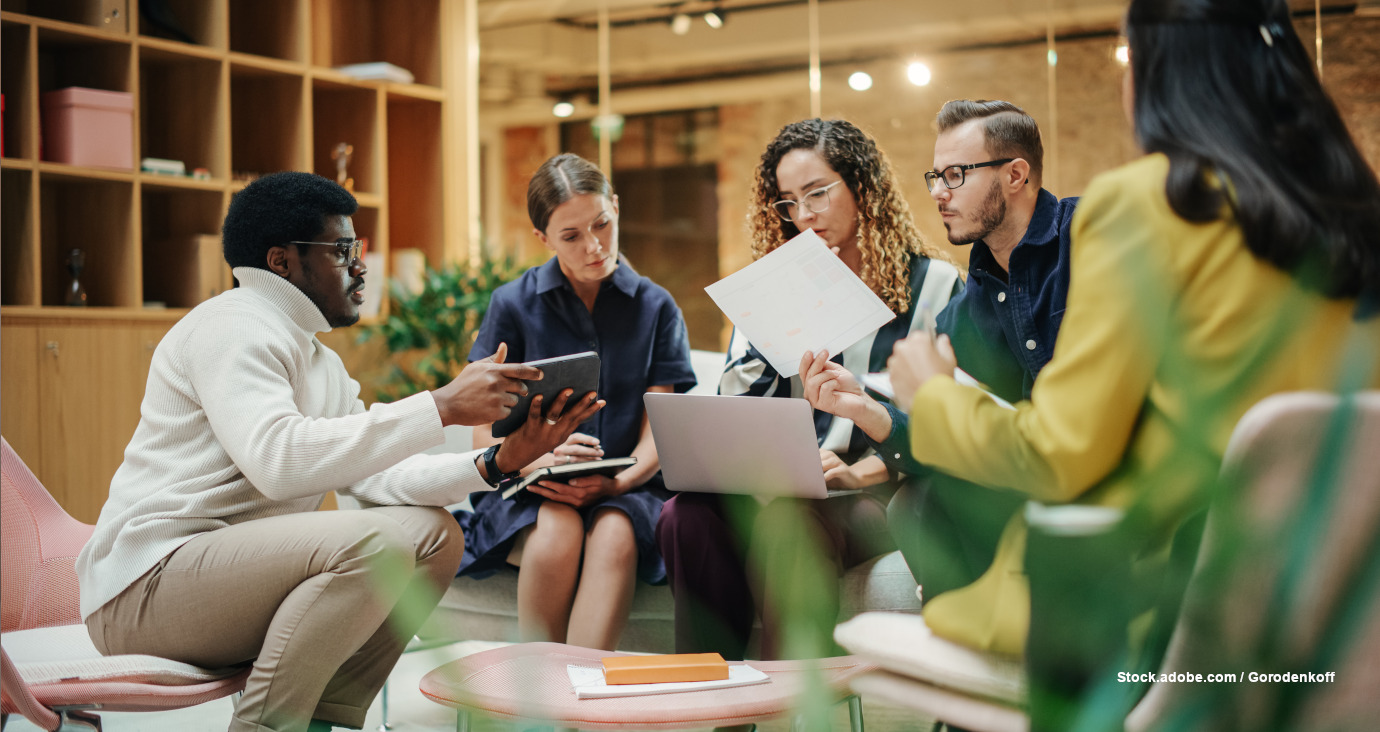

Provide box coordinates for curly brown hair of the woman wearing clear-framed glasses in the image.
[748,119,945,315]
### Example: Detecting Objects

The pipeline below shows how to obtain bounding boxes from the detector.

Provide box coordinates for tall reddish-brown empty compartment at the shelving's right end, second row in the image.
[388,98,446,267]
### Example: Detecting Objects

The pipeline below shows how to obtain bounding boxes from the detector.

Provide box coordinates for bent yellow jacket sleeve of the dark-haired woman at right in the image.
[911,159,1177,501]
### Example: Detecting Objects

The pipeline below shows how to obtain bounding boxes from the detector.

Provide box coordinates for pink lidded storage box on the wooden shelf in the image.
[43,87,134,170]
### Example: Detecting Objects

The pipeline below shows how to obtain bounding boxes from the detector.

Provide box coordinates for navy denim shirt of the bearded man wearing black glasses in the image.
[869,189,1078,475]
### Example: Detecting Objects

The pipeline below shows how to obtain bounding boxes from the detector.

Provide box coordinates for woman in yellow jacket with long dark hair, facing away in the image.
[806,0,1380,655]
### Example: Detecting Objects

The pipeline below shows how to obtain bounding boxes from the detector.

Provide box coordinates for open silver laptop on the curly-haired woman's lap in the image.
[643,394,834,499]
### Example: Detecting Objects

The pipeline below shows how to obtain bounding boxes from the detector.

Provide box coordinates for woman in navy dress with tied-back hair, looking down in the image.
[455,153,694,651]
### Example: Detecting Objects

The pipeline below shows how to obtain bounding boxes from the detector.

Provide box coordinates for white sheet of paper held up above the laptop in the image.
[704,229,896,378]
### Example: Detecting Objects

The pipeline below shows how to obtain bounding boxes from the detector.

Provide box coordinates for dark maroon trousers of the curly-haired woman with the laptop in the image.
[657,493,894,660]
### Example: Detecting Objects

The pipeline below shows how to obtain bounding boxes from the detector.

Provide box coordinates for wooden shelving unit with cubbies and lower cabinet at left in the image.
[0,0,473,521]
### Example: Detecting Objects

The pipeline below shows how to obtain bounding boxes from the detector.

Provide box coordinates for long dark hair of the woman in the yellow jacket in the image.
[1126,0,1380,315]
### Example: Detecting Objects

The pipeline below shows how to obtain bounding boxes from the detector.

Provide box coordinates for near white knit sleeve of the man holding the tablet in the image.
[185,314,460,503]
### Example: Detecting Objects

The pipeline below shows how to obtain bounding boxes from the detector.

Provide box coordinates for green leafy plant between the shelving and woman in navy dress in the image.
[360,253,531,402]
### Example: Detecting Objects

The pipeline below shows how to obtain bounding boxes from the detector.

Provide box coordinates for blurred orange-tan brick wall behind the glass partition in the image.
[491,15,1380,349]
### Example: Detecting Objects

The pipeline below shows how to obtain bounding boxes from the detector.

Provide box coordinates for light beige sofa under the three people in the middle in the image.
[400,351,920,653]
